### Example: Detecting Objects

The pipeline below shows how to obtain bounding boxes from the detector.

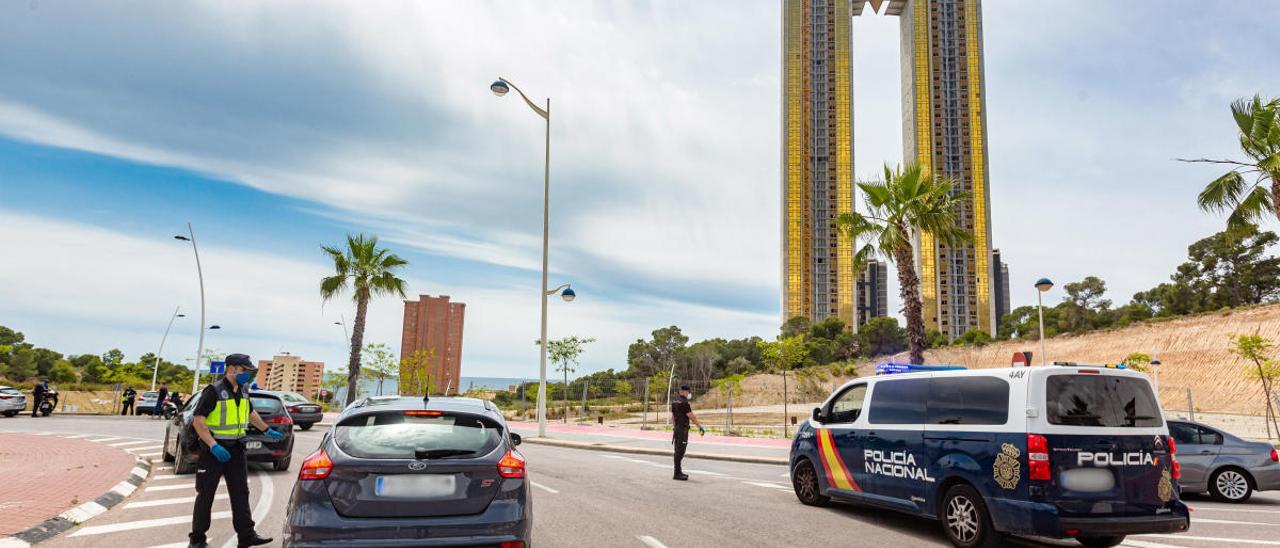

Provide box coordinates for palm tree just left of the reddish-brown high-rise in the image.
[320,234,408,405]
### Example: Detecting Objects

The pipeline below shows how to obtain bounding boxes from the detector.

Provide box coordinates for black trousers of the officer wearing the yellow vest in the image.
[179,442,253,543]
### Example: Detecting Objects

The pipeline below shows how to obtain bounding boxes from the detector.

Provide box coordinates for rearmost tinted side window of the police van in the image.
[928,376,1009,425]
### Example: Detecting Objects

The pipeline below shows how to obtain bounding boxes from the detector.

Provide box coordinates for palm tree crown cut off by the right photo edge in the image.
[1181,95,1280,229]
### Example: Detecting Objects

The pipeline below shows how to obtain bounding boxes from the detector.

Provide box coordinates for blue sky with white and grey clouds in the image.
[0,0,1280,378]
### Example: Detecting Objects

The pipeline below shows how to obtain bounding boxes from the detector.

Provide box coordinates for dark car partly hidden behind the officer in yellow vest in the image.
[163,392,293,474]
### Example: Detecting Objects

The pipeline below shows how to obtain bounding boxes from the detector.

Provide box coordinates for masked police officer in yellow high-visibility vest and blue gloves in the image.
[188,353,284,548]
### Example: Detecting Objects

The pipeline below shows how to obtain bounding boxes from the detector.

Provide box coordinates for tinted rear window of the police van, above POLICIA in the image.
[1044,375,1164,428]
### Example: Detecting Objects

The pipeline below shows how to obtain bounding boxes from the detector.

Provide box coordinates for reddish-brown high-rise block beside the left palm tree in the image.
[399,294,467,396]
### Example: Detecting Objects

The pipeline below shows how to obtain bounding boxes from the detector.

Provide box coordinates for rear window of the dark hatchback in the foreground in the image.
[333,411,502,458]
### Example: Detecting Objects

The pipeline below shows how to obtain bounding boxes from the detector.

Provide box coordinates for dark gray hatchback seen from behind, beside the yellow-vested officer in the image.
[283,396,532,548]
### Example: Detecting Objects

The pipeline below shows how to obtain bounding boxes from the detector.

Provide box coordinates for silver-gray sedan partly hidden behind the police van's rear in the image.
[1169,420,1280,502]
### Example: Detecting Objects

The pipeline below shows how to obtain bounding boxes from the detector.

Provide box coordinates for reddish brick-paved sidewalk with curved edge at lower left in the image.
[0,434,136,538]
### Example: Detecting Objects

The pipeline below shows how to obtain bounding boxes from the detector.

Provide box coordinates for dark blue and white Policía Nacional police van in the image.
[791,364,1190,548]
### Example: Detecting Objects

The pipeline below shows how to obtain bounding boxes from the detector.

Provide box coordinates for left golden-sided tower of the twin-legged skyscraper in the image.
[781,0,855,325]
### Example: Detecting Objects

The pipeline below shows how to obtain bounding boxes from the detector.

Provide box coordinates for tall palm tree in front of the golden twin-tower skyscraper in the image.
[836,164,970,364]
